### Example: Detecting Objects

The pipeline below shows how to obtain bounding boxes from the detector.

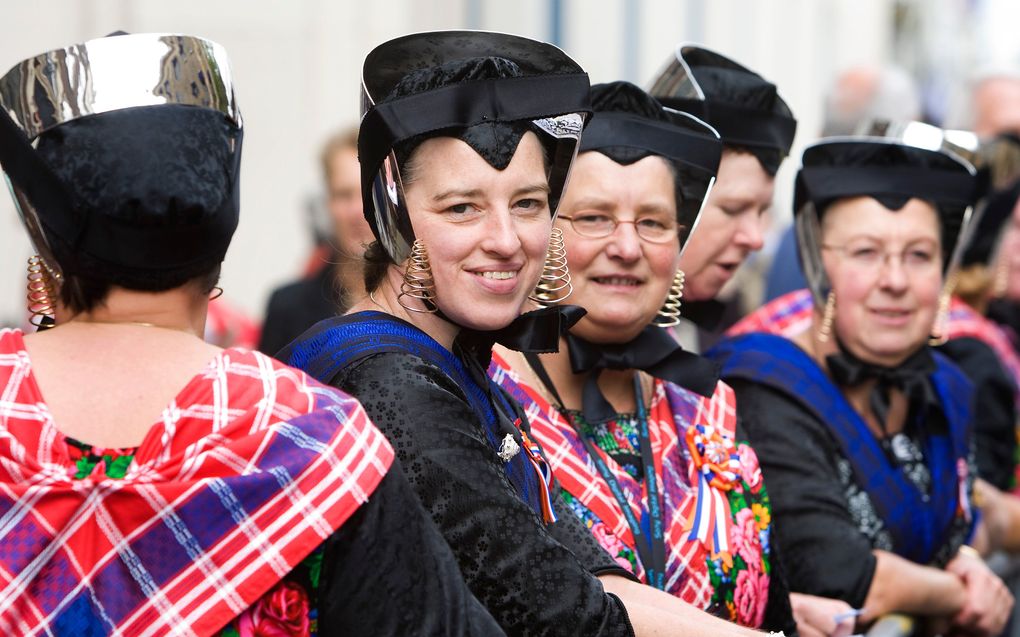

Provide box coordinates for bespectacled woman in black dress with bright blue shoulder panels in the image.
[709,138,1013,635]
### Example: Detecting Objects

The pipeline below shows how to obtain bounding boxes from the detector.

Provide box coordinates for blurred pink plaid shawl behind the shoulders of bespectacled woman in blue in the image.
[726,289,1020,406]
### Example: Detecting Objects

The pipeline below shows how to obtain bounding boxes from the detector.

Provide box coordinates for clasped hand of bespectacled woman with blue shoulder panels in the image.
[946,550,1013,637]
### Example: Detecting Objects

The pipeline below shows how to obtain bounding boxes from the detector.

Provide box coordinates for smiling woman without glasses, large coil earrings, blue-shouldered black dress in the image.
[283,32,771,635]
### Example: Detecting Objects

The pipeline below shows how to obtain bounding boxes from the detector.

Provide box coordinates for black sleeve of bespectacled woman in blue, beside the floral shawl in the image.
[728,379,875,608]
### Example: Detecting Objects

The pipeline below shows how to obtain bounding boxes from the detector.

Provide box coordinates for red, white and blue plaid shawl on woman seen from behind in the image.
[0,330,393,636]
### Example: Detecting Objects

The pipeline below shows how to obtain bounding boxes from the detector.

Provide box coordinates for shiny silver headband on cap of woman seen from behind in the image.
[0,34,242,140]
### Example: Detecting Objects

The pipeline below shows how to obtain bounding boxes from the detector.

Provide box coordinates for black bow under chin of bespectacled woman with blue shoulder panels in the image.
[825,344,938,431]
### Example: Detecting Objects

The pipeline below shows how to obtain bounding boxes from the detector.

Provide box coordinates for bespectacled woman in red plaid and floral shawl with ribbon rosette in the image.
[490,82,820,635]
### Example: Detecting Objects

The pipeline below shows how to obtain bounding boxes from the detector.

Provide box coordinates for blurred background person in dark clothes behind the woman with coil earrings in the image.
[258,126,372,355]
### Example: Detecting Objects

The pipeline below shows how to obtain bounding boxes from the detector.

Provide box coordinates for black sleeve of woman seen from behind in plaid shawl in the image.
[318,461,504,637]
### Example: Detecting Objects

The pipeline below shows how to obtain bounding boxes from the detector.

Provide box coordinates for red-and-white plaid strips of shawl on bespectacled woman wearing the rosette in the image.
[490,354,767,608]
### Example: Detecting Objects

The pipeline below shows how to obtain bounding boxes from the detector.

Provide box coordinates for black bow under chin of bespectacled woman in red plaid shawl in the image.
[567,325,719,423]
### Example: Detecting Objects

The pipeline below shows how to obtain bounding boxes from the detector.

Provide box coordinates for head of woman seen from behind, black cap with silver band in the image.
[0,35,242,312]
